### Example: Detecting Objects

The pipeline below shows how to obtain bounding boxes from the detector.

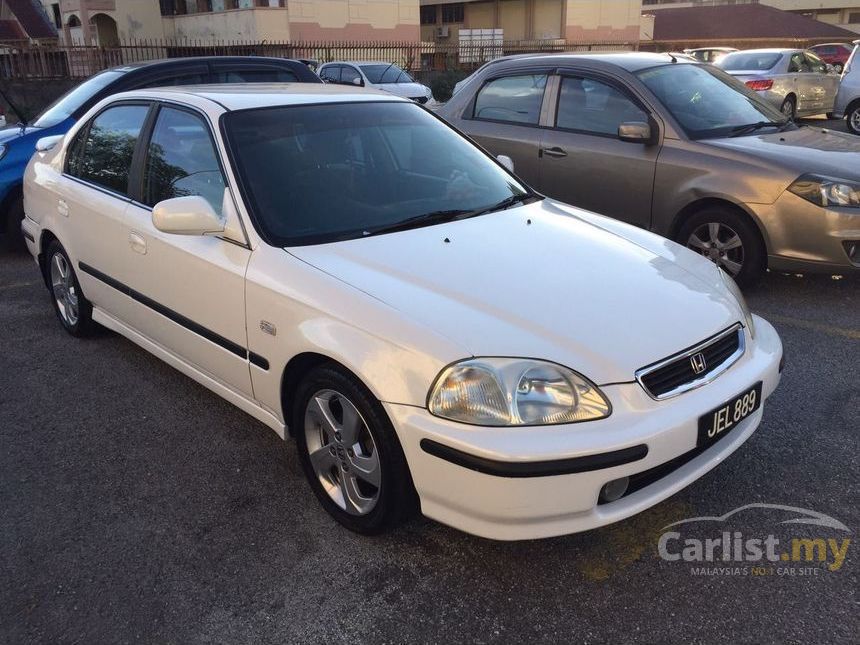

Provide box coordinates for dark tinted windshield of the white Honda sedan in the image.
[224,102,530,246]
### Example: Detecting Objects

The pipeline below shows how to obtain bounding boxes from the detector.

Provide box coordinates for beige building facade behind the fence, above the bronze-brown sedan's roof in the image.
[420,0,642,43]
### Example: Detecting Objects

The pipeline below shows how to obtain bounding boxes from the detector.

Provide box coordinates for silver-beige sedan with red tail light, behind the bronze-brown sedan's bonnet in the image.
[716,49,839,119]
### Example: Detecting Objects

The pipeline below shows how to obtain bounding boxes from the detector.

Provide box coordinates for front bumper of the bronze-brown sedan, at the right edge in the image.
[749,191,860,273]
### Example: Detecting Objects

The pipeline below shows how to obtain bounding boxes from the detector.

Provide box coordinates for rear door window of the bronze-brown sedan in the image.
[474,74,546,125]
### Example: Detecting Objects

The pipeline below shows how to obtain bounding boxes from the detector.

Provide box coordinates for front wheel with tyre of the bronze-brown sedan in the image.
[676,206,767,286]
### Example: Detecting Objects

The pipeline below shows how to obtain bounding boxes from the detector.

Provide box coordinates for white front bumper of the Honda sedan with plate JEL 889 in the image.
[385,318,782,540]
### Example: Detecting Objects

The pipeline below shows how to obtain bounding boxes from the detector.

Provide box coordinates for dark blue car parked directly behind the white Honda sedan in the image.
[0,56,321,246]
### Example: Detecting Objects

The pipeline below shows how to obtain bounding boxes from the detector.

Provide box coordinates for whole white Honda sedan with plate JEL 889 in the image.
[23,84,782,540]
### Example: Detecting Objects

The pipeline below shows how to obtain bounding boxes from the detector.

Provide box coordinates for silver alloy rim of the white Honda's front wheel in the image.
[304,390,382,515]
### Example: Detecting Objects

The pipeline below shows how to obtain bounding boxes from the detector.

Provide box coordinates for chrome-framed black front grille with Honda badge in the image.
[636,324,744,400]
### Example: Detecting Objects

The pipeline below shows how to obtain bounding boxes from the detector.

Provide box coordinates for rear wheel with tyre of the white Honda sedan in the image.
[44,240,95,338]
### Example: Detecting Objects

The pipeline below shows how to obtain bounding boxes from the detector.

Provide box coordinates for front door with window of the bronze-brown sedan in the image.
[538,71,660,228]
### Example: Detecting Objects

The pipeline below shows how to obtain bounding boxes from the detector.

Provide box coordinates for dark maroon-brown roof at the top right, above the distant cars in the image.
[656,4,857,42]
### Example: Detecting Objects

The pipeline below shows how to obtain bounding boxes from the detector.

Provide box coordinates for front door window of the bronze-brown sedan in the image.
[556,76,648,137]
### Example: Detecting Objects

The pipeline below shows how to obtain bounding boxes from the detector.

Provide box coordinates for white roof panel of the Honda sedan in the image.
[111,83,404,111]
